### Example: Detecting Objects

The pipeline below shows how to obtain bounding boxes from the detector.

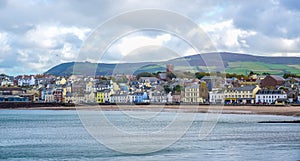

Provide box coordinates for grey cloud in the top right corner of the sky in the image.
[225,1,300,38]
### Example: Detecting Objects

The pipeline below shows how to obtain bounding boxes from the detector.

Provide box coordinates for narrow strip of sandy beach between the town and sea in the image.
[0,105,300,117]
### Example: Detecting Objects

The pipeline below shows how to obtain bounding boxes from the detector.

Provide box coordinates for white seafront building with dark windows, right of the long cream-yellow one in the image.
[255,90,287,104]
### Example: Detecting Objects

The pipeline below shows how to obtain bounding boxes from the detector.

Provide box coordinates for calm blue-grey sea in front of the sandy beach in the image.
[0,110,300,161]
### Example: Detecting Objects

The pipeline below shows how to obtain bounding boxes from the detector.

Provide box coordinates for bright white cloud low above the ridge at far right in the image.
[201,20,300,56]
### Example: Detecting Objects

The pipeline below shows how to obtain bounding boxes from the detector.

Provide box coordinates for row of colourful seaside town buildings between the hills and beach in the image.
[0,65,300,105]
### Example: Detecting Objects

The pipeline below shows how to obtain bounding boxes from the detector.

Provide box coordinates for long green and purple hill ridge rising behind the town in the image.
[45,52,300,76]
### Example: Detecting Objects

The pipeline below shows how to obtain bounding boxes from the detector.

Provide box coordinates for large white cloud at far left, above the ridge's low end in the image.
[0,25,90,74]
